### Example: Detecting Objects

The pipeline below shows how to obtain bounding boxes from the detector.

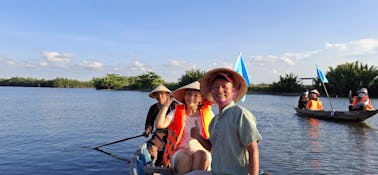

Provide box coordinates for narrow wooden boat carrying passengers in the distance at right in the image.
[294,107,378,122]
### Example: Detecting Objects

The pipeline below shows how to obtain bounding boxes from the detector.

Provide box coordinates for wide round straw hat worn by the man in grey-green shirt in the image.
[201,68,248,102]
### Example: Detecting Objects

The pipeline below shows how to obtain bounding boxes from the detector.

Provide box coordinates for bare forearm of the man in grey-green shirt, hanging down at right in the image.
[247,141,260,175]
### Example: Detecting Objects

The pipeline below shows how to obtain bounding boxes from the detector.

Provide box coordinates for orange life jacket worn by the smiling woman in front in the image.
[163,101,213,166]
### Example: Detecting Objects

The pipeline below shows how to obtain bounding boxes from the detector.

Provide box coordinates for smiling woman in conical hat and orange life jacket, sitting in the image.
[155,81,213,174]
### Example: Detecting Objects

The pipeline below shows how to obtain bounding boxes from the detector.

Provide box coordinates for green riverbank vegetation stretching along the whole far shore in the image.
[0,61,378,97]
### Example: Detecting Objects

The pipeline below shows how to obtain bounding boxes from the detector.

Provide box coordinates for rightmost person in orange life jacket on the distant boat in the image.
[349,88,374,111]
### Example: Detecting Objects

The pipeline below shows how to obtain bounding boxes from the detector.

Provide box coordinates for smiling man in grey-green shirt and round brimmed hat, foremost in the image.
[191,68,262,175]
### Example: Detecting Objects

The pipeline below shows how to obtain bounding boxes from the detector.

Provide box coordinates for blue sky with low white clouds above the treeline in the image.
[0,0,378,84]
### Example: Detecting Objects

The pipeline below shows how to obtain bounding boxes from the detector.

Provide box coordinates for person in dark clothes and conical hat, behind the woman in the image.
[143,84,175,166]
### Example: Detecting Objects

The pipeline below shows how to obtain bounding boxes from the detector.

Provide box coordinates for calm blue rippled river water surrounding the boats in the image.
[0,87,378,175]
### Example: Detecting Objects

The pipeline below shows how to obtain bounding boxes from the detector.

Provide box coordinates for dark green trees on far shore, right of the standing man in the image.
[255,61,378,98]
